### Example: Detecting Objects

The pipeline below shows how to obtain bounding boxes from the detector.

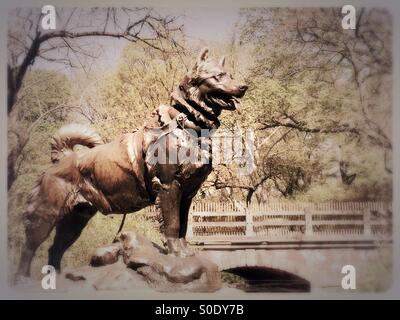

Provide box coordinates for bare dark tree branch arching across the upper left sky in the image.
[7,8,184,114]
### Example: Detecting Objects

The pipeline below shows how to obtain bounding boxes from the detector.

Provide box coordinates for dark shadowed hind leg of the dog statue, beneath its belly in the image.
[49,204,97,271]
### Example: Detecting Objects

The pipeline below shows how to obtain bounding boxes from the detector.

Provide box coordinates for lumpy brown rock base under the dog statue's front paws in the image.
[65,232,221,292]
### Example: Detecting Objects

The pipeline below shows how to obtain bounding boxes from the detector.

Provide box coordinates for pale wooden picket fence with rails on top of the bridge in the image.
[183,202,392,243]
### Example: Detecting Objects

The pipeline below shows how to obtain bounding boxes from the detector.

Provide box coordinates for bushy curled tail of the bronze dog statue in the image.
[50,123,104,163]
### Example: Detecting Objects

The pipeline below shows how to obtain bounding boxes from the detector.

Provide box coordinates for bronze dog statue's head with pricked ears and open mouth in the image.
[179,48,248,117]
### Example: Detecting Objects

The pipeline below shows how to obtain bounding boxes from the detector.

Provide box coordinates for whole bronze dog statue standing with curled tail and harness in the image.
[17,49,247,276]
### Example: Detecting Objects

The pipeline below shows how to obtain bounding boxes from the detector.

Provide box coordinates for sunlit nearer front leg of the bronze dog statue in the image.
[158,180,182,256]
